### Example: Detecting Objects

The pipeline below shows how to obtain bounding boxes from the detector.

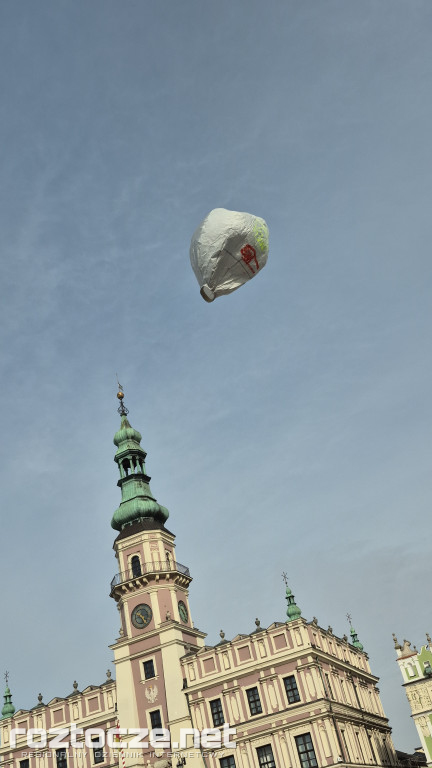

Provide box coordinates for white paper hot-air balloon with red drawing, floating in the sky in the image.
[190,208,268,302]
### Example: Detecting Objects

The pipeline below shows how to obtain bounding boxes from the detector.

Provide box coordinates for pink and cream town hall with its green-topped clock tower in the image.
[0,390,398,768]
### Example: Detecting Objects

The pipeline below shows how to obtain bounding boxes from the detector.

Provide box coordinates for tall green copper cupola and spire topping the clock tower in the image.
[111,386,169,531]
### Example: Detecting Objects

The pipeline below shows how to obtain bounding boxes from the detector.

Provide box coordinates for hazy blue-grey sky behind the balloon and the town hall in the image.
[0,0,432,751]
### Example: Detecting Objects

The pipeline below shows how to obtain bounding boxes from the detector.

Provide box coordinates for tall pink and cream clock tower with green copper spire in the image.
[111,388,205,767]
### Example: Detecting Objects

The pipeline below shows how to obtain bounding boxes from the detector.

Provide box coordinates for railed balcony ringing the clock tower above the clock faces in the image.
[110,560,192,599]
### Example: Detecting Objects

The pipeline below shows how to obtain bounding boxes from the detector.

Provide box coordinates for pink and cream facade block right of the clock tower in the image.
[181,618,397,768]
